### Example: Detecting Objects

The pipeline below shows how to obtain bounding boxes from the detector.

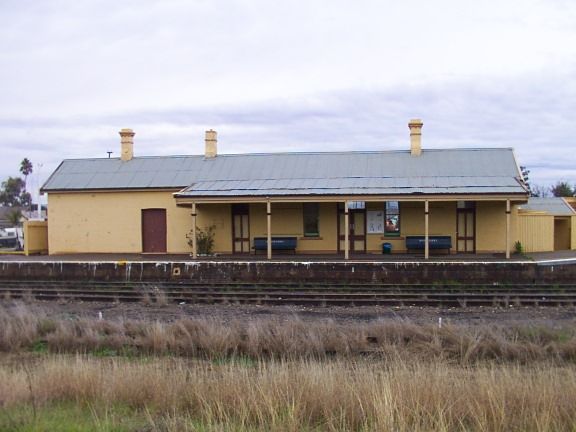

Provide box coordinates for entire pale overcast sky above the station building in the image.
[0,0,576,200]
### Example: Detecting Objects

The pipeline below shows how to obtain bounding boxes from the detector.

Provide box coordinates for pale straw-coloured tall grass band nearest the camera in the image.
[0,356,576,431]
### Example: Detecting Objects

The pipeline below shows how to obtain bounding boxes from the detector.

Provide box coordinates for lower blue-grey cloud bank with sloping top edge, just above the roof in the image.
[0,70,576,192]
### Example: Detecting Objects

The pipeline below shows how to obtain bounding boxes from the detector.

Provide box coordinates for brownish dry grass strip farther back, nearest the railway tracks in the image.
[0,304,576,365]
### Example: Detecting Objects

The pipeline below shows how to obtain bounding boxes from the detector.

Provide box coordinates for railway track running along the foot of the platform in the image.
[0,280,576,307]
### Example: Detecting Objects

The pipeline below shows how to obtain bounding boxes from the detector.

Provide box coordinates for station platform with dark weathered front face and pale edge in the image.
[0,254,576,286]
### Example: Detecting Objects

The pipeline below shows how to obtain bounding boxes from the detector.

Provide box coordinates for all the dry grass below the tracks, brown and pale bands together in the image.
[0,304,576,432]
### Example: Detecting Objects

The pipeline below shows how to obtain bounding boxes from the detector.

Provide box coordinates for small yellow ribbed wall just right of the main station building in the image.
[515,214,554,252]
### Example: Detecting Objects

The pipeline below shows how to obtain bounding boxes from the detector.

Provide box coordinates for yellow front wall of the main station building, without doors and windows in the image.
[48,191,524,254]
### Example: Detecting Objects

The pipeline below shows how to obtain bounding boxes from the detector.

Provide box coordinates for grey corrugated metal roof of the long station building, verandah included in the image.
[42,149,525,196]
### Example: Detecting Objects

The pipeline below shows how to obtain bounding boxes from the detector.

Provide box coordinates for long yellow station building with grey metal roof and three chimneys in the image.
[42,120,576,259]
